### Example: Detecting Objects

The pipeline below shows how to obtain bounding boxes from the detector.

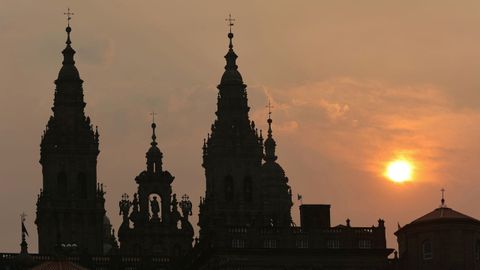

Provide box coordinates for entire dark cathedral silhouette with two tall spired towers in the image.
[0,15,480,270]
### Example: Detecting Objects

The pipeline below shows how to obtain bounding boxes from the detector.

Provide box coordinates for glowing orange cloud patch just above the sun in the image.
[263,77,480,185]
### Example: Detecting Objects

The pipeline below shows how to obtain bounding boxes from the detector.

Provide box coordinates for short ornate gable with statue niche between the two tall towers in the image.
[118,122,193,258]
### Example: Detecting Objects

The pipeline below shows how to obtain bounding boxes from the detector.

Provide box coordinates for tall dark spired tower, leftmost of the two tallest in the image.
[35,18,105,254]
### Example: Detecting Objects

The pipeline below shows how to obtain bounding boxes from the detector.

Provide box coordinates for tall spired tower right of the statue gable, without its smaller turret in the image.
[199,18,263,247]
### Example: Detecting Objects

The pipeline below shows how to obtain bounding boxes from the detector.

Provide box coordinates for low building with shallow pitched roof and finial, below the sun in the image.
[395,199,480,270]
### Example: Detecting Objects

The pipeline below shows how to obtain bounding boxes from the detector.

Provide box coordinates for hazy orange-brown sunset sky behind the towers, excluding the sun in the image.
[0,0,480,252]
